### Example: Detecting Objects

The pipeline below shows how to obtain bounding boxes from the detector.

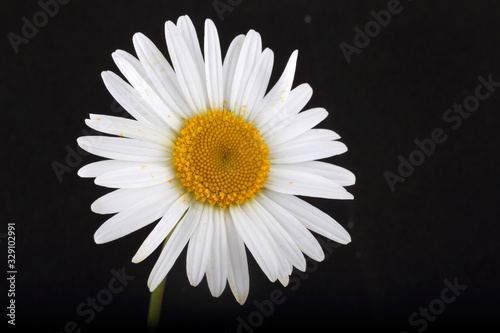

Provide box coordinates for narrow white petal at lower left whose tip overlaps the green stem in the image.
[148,202,202,291]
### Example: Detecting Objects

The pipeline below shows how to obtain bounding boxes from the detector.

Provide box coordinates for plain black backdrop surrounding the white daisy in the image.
[0,0,500,332]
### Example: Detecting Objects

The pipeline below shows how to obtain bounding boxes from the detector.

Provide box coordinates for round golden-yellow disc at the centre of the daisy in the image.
[172,109,271,208]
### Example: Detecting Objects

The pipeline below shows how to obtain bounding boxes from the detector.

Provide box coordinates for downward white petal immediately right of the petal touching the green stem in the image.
[186,206,214,286]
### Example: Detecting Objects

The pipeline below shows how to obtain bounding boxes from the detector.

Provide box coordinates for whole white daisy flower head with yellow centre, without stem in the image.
[78,16,355,304]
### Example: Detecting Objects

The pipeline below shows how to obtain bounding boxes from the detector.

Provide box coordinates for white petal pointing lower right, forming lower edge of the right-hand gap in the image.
[263,190,351,244]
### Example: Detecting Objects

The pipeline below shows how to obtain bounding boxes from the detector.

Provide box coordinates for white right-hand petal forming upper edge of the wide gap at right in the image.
[266,164,354,199]
